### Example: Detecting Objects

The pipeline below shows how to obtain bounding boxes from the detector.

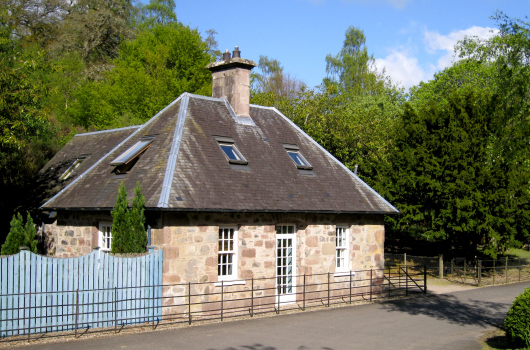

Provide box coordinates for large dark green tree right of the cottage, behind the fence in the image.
[375,91,530,257]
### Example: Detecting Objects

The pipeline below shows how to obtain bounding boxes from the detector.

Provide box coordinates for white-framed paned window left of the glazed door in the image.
[217,226,238,281]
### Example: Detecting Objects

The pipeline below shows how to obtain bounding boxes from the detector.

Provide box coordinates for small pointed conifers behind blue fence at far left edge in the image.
[0,212,37,255]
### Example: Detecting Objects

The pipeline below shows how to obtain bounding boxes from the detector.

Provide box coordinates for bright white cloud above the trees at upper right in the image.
[375,27,497,89]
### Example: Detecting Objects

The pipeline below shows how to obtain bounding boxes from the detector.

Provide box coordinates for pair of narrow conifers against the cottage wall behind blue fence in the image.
[111,182,147,253]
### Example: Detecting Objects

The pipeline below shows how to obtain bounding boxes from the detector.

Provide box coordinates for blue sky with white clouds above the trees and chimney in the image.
[176,0,530,88]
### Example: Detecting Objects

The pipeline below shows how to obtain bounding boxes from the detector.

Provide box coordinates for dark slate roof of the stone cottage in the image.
[41,93,398,214]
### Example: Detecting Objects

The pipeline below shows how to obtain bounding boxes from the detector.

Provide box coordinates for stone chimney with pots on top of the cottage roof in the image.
[206,46,257,117]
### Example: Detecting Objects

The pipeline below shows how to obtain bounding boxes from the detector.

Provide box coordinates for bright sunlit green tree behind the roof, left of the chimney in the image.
[69,23,212,129]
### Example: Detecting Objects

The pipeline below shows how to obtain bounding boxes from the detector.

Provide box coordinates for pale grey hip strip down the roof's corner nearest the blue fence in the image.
[157,93,190,208]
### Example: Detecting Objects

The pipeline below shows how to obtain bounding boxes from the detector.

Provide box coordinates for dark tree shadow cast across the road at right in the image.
[383,294,510,327]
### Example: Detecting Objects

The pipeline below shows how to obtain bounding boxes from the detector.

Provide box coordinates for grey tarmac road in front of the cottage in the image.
[14,282,530,350]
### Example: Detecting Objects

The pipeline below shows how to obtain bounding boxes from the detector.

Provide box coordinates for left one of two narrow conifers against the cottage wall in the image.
[111,182,131,253]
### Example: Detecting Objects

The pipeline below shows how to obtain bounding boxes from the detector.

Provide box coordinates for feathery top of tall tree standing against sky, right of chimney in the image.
[324,26,391,95]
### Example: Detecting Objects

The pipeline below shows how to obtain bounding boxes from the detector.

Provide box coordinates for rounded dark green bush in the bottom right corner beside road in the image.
[504,288,530,348]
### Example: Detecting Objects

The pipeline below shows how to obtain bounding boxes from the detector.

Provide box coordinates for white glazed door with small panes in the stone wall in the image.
[276,225,296,303]
